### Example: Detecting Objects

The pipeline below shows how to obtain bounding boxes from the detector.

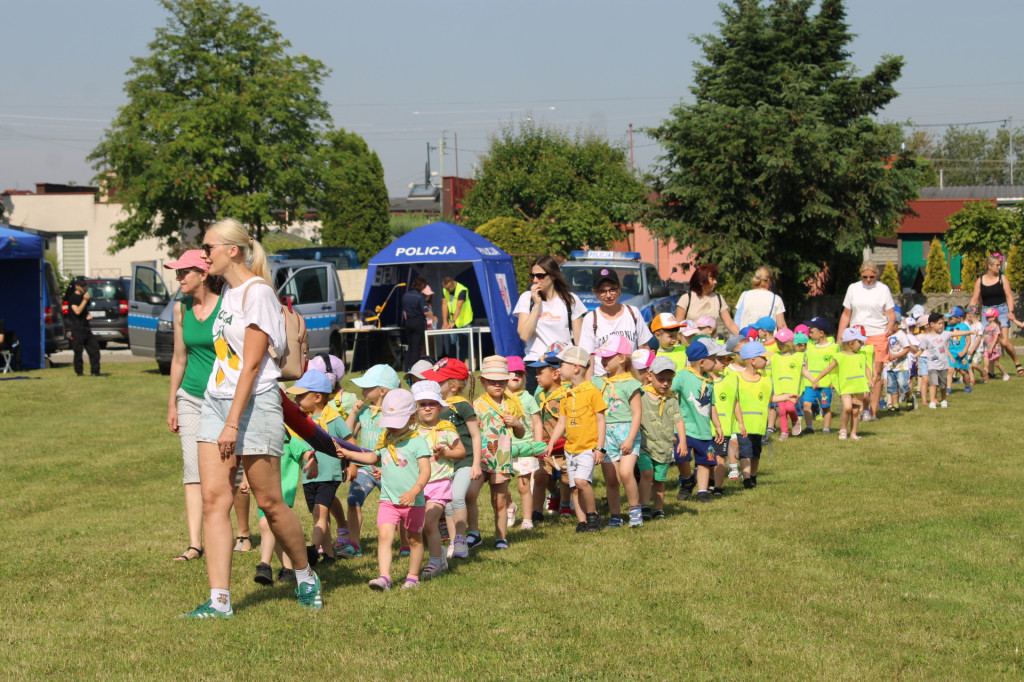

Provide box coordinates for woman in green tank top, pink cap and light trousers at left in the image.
[164,249,225,561]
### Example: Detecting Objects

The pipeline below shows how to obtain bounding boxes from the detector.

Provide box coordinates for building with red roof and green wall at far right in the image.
[896,184,1024,290]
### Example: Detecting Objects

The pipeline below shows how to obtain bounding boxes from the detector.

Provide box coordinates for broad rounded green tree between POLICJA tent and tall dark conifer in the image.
[463,119,646,253]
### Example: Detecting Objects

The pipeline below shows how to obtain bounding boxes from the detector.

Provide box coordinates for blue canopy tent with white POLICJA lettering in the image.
[362,222,522,355]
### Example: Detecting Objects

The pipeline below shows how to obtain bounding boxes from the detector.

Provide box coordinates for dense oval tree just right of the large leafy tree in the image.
[317,130,391,267]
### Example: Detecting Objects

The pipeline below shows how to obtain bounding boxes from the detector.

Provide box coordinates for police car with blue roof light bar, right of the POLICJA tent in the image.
[561,251,676,323]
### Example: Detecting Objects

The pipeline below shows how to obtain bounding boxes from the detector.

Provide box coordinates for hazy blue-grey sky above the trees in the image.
[0,0,1024,196]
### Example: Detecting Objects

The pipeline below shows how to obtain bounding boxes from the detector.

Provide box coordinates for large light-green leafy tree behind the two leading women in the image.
[89,0,330,251]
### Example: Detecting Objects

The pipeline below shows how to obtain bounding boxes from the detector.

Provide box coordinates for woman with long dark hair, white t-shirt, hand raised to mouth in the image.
[512,256,587,393]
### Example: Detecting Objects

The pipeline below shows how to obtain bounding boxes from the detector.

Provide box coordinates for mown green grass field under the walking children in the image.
[0,364,1024,680]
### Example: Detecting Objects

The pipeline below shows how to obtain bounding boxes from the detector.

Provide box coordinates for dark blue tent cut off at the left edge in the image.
[0,225,46,370]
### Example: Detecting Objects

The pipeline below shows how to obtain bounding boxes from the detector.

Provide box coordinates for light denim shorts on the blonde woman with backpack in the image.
[196,388,285,457]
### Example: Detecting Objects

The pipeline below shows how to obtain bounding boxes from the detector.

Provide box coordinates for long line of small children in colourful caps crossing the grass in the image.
[245,306,1009,591]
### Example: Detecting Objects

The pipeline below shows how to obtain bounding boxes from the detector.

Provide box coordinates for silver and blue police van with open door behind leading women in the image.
[136,259,345,374]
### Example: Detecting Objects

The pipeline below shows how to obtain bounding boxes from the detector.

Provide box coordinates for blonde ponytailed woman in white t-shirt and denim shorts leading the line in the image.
[184,220,323,619]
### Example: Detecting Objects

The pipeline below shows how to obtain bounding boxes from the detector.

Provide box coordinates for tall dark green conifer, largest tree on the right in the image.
[648,0,921,296]
